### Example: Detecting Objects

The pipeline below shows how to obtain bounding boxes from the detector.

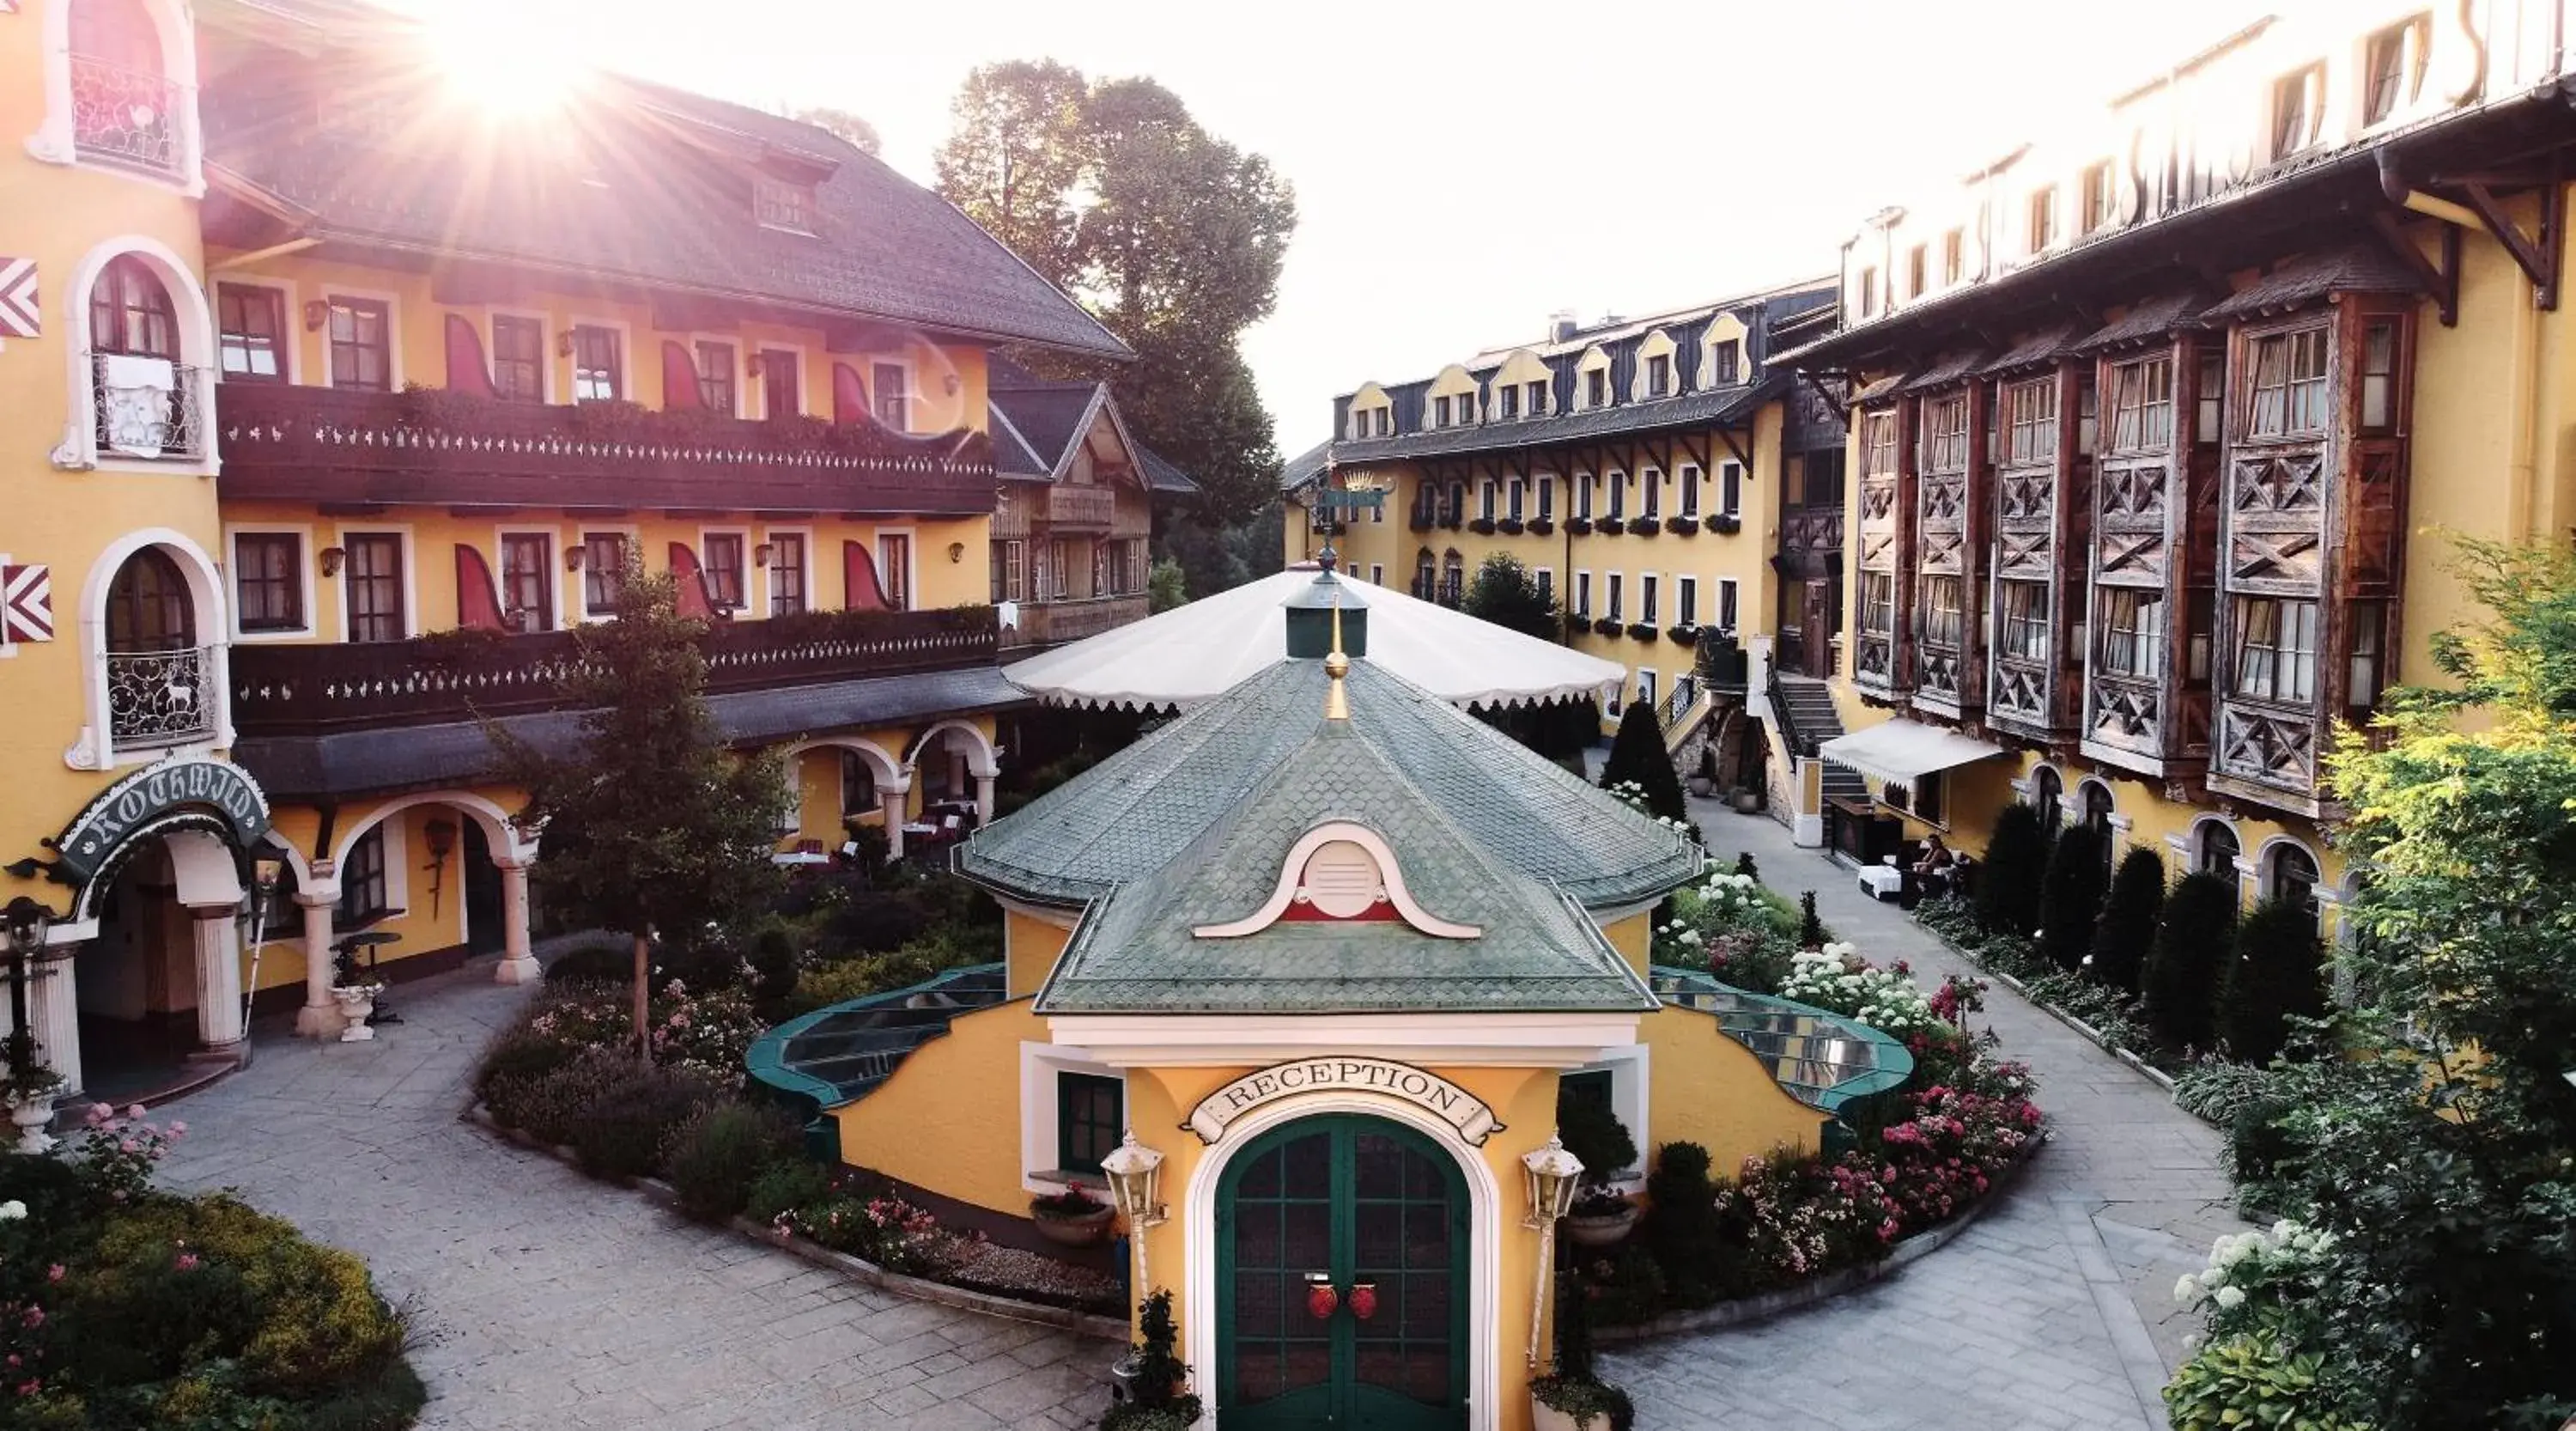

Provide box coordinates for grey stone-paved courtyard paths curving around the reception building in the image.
[146,802,2236,1431]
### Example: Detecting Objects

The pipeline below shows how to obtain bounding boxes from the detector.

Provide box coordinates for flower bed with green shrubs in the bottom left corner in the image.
[0,1106,428,1431]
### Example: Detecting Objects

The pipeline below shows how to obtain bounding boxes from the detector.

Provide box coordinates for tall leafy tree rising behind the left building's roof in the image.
[938,59,1296,526]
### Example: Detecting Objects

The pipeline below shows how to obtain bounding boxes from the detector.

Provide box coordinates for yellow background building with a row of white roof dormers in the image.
[1283,281,1842,789]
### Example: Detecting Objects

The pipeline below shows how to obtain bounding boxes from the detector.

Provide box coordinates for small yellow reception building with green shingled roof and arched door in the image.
[750,572,1911,1431]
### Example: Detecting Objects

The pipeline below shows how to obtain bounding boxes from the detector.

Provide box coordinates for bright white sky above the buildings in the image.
[399,0,2264,456]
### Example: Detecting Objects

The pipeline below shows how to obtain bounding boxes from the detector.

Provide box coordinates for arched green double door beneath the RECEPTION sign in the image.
[1216,1114,1468,1431]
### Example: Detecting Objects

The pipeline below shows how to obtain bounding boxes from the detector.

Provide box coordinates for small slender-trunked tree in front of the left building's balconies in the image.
[484,559,786,1065]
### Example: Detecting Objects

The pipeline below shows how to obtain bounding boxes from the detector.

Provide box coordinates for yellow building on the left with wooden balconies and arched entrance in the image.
[0,0,1141,1091]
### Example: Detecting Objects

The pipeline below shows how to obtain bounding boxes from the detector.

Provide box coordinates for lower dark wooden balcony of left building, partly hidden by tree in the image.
[232,608,999,738]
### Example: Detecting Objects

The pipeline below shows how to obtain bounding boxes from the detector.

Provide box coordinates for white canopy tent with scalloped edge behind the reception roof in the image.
[1002,564,1628,709]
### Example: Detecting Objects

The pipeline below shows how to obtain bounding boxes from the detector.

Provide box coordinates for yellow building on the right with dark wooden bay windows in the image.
[1788,0,2576,923]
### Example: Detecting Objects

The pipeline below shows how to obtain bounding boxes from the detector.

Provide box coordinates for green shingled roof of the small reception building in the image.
[958,660,1700,1014]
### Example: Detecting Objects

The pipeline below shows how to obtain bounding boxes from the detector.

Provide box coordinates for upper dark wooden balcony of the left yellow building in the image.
[216,381,994,515]
